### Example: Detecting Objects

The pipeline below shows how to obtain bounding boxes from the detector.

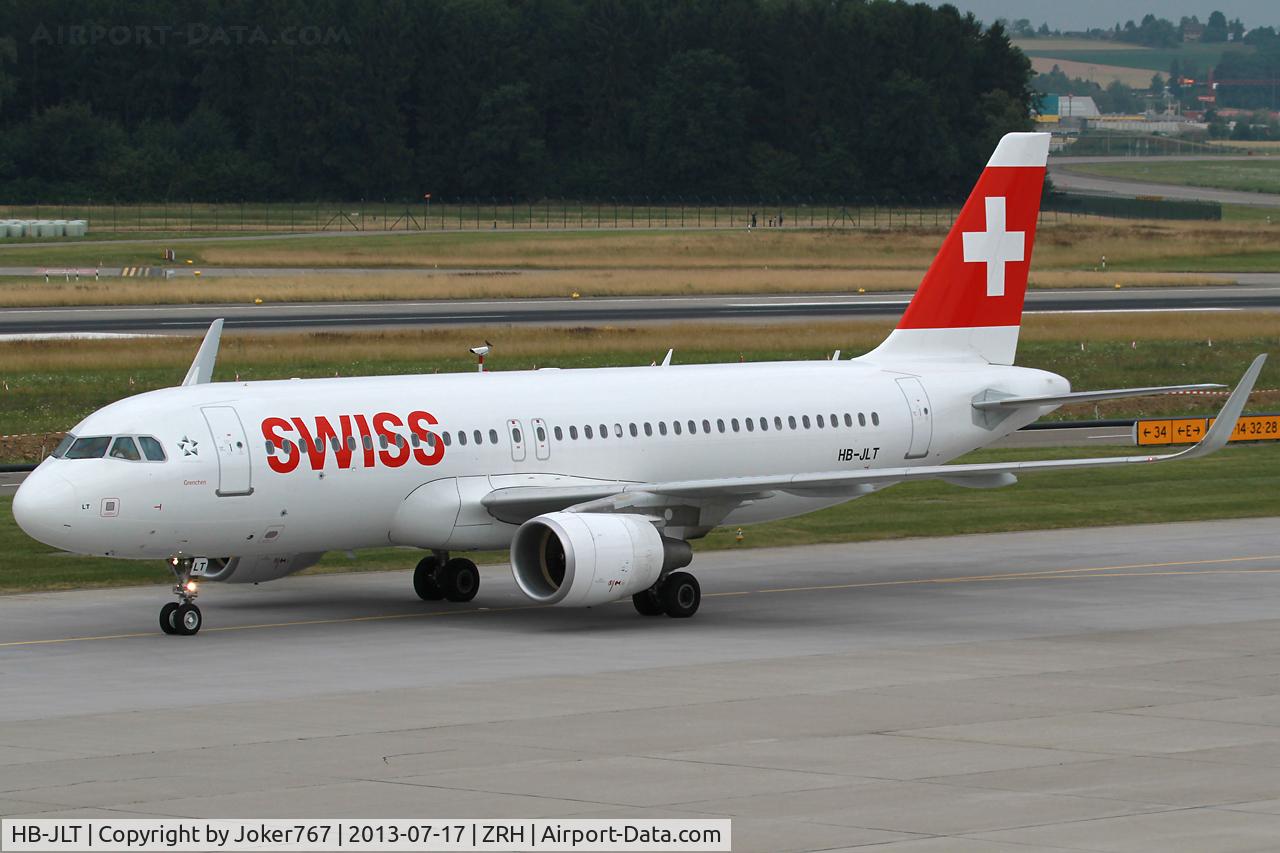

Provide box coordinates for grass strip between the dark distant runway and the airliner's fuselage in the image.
[0,311,1280,438]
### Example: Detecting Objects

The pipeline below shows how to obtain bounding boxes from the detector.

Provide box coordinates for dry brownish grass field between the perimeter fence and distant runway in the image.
[0,218,1276,307]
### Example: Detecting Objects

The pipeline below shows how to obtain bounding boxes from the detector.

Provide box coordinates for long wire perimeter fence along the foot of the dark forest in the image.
[0,190,1221,240]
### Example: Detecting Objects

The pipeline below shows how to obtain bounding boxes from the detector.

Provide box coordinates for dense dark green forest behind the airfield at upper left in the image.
[0,0,1032,202]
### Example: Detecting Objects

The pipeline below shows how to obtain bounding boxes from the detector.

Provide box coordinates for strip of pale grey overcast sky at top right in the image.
[928,0,1280,29]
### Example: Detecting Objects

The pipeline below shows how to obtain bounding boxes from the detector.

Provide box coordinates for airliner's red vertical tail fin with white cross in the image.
[872,133,1048,364]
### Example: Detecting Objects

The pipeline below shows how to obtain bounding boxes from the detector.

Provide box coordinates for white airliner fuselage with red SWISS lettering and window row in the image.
[15,360,1068,558]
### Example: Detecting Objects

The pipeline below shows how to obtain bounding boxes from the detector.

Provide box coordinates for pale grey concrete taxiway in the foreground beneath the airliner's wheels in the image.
[0,516,1280,853]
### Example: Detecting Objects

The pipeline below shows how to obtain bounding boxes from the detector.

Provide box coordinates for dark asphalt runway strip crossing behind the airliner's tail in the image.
[0,285,1280,334]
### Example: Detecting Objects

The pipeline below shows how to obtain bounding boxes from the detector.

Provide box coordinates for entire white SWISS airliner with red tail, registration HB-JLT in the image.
[13,133,1265,634]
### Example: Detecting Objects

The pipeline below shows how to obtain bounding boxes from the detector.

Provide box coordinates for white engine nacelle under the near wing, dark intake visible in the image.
[511,512,692,607]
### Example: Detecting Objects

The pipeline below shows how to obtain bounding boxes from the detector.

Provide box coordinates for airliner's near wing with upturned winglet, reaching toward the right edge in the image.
[481,355,1266,524]
